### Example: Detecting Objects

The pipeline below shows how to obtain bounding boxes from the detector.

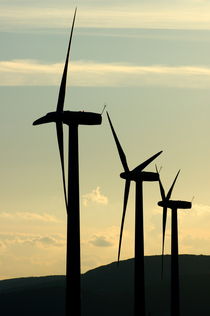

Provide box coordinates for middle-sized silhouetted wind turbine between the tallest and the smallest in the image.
[107,112,162,316]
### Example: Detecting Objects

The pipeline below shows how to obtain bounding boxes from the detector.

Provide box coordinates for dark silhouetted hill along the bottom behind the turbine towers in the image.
[0,255,210,316]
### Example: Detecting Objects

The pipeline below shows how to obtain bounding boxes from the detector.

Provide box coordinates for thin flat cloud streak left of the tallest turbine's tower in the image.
[0,212,60,223]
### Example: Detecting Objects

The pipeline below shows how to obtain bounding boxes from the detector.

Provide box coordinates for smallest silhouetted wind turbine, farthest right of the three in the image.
[156,167,192,316]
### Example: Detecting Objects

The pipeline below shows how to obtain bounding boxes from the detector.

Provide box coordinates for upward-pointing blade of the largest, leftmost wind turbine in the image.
[57,8,77,112]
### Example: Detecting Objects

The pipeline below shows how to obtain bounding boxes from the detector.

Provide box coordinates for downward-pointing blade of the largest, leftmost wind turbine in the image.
[56,122,68,211]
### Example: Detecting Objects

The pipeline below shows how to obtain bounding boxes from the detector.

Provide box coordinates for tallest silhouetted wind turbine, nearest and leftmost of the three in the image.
[33,9,102,316]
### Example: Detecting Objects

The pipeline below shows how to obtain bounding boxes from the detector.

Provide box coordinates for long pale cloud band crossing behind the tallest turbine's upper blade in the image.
[0,60,210,89]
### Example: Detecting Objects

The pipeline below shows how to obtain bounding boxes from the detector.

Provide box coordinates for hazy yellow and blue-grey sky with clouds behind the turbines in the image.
[0,0,210,279]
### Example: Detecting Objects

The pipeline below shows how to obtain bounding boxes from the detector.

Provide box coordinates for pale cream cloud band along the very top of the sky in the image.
[0,0,210,30]
